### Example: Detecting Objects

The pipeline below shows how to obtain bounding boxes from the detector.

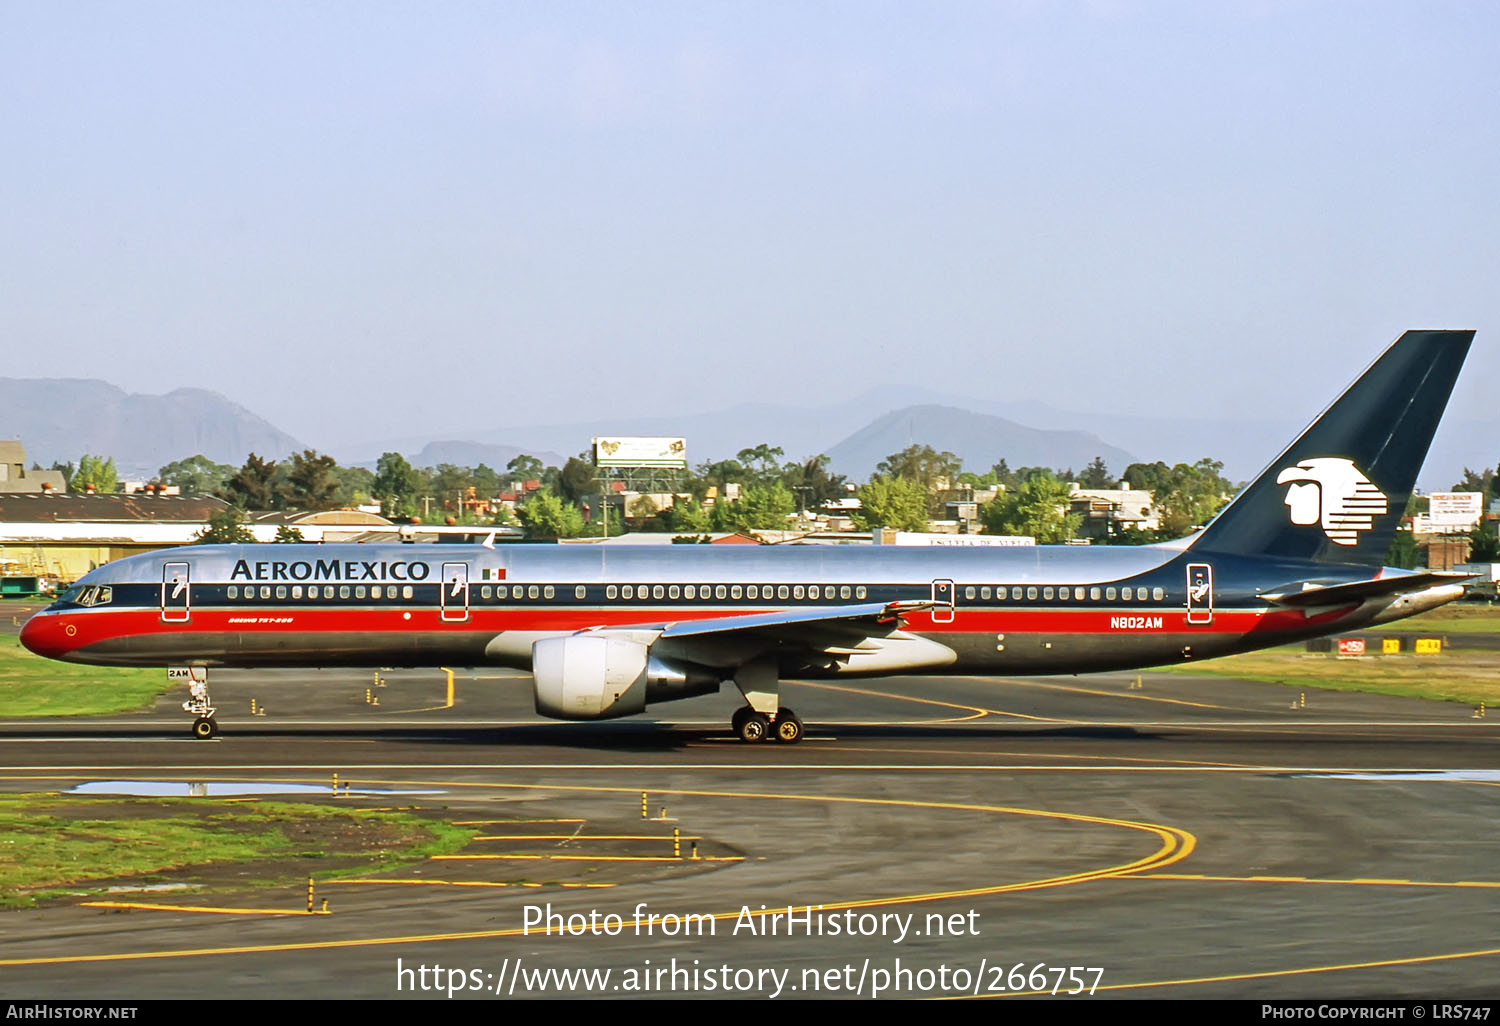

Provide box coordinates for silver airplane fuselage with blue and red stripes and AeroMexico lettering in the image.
[14,545,1463,678]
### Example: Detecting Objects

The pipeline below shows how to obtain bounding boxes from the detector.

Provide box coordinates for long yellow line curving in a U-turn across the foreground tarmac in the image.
[0,783,1197,966]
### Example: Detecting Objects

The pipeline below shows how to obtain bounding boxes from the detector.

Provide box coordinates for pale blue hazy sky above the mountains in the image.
[0,0,1500,449]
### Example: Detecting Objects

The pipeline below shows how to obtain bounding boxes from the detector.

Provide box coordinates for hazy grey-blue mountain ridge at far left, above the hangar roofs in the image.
[0,378,306,477]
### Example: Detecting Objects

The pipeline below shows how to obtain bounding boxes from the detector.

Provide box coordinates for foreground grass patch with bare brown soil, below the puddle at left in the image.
[0,795,476,908]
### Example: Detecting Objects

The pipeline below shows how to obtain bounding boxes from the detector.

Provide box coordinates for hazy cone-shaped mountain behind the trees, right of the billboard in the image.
[827,405,1136,480]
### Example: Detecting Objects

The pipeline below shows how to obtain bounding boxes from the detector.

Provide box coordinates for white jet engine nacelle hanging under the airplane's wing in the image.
[531,635,720,720]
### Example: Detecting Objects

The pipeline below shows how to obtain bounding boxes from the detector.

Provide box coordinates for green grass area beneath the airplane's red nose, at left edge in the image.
[0,638,173,719]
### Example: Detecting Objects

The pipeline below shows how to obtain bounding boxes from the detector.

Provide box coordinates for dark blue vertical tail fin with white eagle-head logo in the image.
[1191,332,1475,567]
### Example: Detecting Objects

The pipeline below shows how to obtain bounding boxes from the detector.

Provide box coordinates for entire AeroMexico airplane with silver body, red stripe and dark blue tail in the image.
[21,332,1475,743]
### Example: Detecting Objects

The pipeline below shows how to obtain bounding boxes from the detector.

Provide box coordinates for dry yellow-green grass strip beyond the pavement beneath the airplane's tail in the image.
[1161,645,1500,705]
